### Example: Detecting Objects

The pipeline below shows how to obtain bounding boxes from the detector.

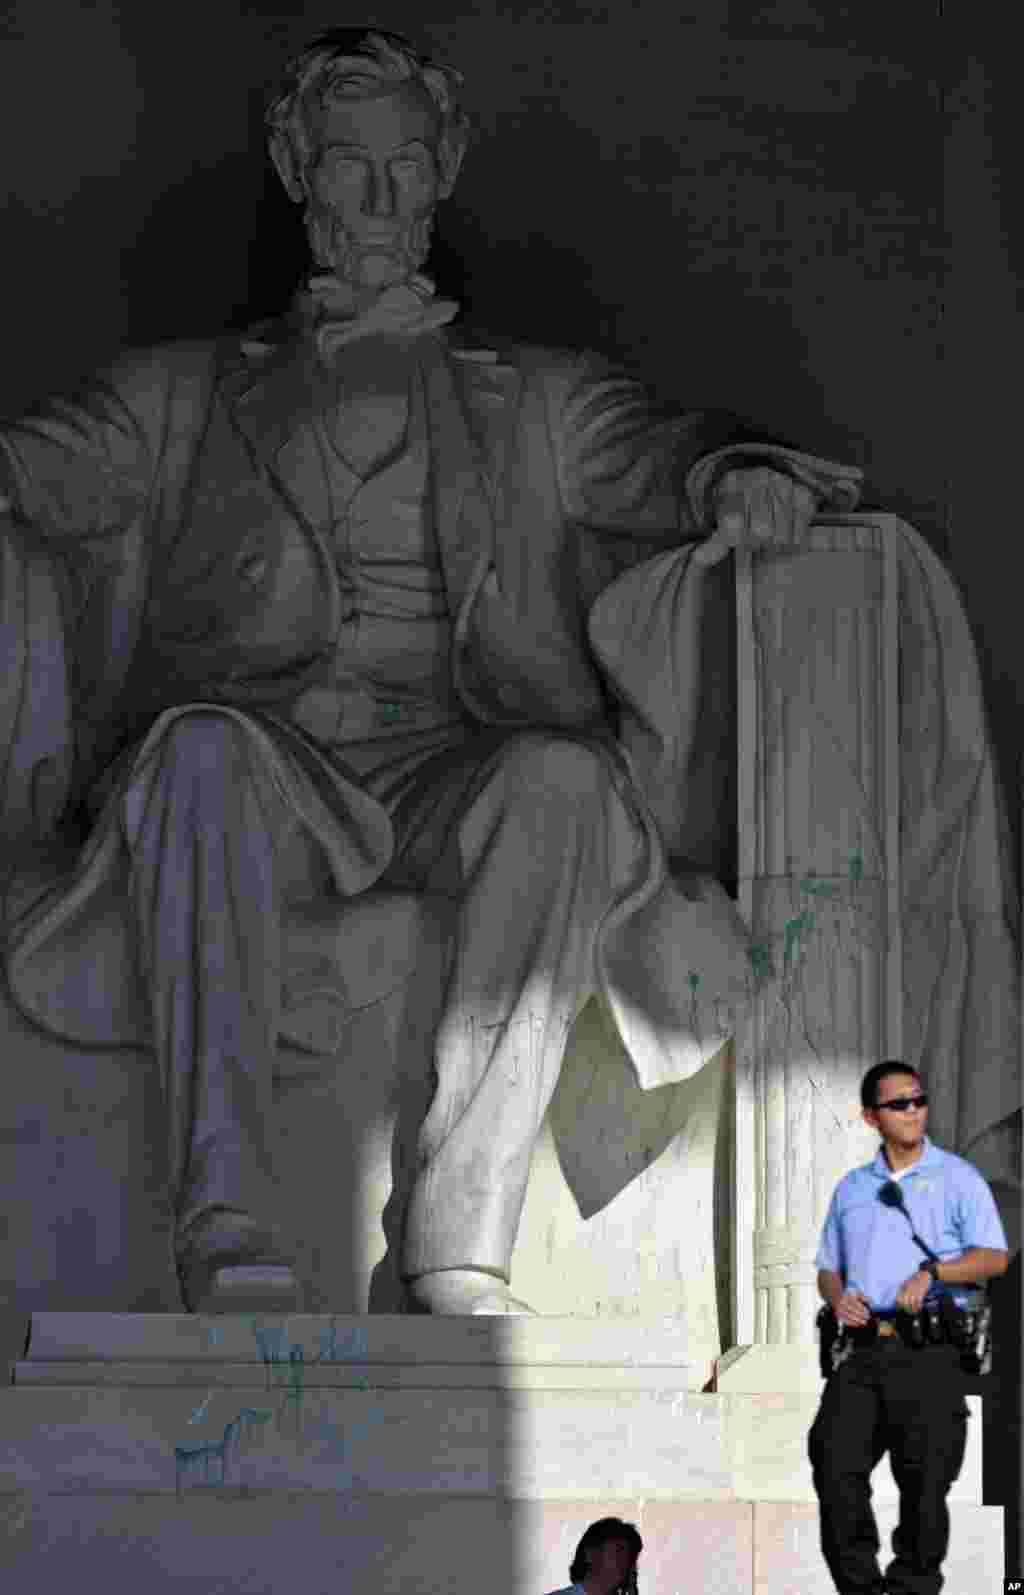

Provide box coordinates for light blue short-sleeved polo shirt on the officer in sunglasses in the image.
[815,1136,1006,1313]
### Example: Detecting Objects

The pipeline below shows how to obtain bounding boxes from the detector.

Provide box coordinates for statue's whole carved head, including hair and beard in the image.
[266,27,469,293]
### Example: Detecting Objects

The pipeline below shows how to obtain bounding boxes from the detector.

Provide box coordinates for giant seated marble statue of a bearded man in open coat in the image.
[0,29,860,1314]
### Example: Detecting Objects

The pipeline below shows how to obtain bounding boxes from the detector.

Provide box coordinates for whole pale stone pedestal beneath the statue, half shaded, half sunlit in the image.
[0,1313,1002,1595]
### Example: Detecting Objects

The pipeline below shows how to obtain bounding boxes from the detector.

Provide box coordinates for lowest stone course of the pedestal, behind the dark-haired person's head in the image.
[0,1490,1003,1595]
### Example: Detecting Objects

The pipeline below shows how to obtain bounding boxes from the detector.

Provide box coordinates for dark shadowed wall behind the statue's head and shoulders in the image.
[0,0,1024,1566]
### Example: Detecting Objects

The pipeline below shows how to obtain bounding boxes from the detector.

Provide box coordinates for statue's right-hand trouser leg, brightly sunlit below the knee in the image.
[402,734,644,1281]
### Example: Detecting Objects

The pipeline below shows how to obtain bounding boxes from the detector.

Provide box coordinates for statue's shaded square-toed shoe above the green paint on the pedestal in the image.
[177,1214,300,1313]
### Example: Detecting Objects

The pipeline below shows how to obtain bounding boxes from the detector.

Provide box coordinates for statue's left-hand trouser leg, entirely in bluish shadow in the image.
[123,710,296,1236]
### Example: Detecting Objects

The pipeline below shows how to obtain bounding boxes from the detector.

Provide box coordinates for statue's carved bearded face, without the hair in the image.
[305,83,442,290]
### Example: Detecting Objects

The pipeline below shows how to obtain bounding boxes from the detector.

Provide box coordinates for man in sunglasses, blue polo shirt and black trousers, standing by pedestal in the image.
[809,1061,1010,1595]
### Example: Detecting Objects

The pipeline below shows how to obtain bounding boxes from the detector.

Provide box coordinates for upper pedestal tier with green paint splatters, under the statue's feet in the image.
[0,1314,981,1504]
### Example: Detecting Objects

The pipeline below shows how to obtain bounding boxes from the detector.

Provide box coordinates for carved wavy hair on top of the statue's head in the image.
[265,27,469,194]
